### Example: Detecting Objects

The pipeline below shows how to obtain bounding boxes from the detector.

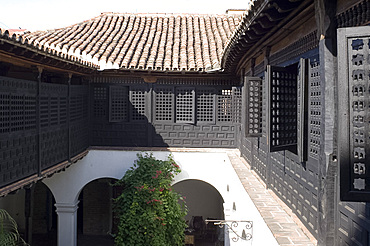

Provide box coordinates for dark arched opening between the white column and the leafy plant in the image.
[77,178,115,246]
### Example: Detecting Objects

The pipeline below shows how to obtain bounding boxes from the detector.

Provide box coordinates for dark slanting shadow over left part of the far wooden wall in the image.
[90,85,168,147]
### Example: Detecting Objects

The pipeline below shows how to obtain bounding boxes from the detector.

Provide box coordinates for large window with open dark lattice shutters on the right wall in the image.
[266,59,308,162]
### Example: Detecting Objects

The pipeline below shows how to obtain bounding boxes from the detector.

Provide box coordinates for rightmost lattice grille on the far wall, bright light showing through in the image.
[217,90,233,122]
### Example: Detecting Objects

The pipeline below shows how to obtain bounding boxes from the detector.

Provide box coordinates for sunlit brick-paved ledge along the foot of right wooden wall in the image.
[227,150,317,246]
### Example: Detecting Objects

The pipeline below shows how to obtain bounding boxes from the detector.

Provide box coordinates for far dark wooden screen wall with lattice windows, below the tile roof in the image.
[91,80,241,147]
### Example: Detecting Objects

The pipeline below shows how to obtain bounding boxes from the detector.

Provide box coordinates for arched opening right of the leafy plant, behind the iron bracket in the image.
[173,179,225,245]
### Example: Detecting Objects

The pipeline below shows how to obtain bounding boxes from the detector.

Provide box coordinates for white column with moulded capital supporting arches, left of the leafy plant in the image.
[55,201,79,246]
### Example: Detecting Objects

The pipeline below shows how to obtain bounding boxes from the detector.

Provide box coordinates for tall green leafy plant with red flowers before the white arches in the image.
[114,153,186,246]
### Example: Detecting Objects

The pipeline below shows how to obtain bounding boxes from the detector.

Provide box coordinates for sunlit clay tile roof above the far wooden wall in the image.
[23,13,242,71]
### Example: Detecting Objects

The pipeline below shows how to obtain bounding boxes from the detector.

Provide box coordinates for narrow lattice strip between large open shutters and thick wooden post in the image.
[309,62,322,160]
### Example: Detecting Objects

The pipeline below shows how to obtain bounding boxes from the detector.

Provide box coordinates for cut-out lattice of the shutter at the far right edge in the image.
[348,38,370,191]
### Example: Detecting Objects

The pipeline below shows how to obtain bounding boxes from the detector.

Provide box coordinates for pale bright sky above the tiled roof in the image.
[0,0,249,31]
